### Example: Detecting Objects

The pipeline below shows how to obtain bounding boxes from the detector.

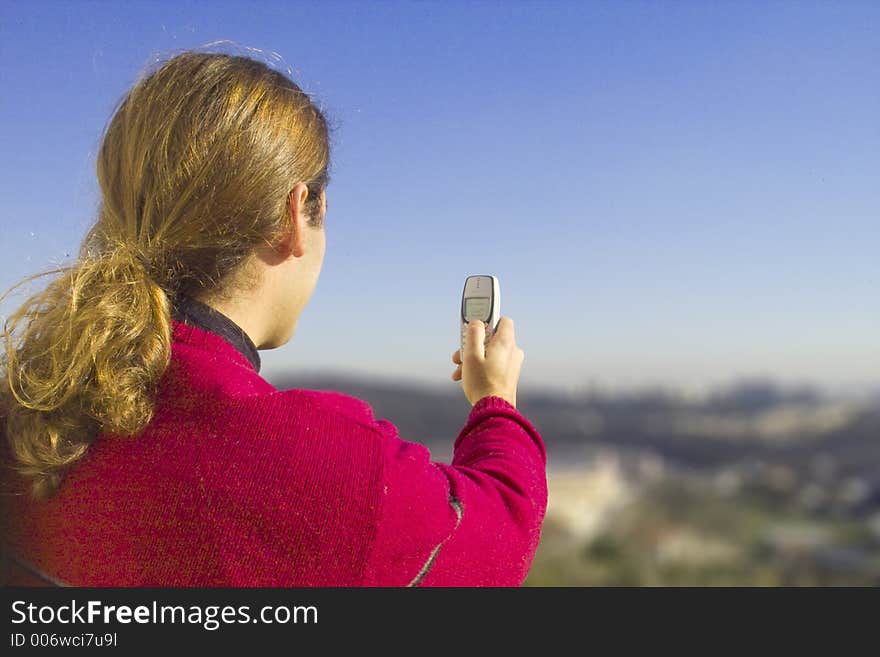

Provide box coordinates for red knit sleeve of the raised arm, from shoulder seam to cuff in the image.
[364,396,547,586]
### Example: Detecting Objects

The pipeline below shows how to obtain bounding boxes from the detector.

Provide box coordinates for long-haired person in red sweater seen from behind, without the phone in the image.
[0,51,547,586]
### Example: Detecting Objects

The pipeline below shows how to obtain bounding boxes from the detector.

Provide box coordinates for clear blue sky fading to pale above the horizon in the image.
[0,0,880,389]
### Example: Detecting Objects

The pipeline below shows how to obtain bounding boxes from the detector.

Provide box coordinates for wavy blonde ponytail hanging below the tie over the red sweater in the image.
[0,245,171,498]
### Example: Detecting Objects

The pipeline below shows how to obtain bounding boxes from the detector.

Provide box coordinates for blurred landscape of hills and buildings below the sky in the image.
[272,374,880,586]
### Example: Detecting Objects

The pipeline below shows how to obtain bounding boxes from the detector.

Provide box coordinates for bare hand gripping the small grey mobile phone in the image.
[452,317,525,406]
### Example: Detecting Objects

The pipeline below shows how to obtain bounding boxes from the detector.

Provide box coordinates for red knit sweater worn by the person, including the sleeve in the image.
[3,320,547,586]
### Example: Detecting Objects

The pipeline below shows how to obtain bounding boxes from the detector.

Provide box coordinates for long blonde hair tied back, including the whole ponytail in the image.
[0,50,330,498]
